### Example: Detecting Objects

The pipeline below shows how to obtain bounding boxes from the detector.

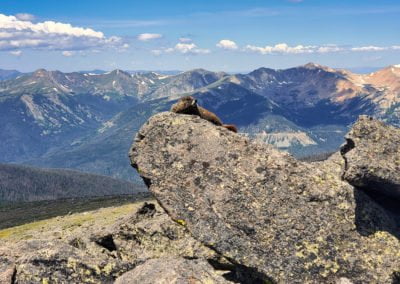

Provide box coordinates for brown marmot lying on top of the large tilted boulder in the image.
[171,96,237,132]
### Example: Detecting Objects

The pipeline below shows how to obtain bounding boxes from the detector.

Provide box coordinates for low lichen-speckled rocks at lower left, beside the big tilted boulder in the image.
[0,202,224,283]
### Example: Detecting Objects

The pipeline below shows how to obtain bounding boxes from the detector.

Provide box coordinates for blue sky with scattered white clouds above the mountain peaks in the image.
[0,0,400,72]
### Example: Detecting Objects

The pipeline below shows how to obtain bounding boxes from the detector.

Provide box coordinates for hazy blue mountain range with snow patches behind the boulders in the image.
[0,63,400,181]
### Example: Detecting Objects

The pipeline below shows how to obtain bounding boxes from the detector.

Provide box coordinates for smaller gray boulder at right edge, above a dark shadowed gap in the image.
[342,116,400,201]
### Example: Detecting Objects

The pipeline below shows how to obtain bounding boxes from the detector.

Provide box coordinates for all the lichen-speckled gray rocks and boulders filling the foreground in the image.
[0,113,400,283]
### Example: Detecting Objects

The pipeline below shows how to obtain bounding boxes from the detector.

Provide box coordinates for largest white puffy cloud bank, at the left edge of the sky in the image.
[0,14,124,50]
